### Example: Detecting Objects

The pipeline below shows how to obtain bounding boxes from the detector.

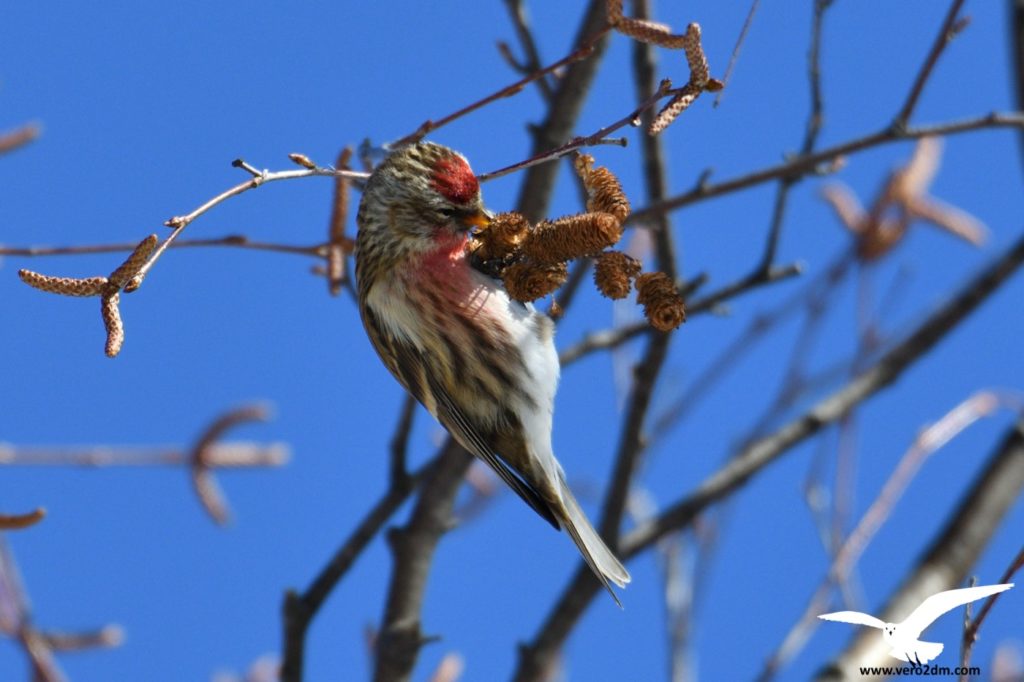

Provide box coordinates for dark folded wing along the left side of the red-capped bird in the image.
[362,307,560,528]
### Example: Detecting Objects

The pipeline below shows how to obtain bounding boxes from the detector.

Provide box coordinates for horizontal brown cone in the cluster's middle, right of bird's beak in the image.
[522,213,623,264]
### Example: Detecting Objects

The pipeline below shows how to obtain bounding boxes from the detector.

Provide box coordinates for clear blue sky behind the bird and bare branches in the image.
[0,0,1024,682]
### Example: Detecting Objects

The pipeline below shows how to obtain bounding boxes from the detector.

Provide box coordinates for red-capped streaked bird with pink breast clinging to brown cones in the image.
[355,142,630,606]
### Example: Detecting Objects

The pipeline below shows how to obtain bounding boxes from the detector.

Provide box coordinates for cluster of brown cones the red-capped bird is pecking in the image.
[470,154,686,332]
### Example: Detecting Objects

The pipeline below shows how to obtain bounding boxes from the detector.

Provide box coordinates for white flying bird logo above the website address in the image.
[818,583,1014,666]
